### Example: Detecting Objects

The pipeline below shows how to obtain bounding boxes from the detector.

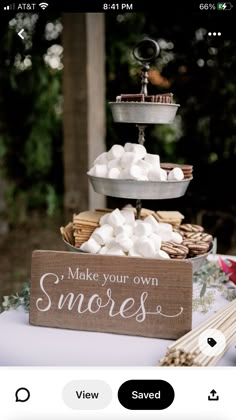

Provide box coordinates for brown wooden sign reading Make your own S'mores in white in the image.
[30,251,192,338]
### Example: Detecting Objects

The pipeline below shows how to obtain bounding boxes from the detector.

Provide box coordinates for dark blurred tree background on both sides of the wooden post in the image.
[0,10,236,252]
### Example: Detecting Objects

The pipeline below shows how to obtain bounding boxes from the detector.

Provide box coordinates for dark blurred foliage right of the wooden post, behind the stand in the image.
[106,13,236,214]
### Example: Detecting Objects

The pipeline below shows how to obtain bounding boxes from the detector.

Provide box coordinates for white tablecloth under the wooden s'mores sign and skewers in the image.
[0,253,236,366]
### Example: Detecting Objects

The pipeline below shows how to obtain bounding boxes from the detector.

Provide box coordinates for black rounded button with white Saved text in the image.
[118,379,175,410]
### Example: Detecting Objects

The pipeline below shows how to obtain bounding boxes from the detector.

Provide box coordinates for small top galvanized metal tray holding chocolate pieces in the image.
[109,102,180,124]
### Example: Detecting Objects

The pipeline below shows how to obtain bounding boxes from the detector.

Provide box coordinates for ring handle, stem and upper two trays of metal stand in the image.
[88,38,192,218]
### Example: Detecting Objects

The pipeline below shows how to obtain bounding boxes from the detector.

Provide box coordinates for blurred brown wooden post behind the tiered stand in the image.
[63,13,105,214]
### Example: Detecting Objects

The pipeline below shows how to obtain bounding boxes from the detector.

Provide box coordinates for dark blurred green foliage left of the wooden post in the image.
[0,14,63,222]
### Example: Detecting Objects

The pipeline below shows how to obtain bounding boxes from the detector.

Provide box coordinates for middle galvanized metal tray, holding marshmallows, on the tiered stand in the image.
[87,173,193,200]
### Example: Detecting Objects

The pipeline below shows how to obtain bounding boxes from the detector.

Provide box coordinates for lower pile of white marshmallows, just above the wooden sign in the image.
[80,208,183,259]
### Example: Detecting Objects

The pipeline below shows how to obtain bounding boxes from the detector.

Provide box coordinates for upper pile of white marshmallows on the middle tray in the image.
[88,143,184,181]
